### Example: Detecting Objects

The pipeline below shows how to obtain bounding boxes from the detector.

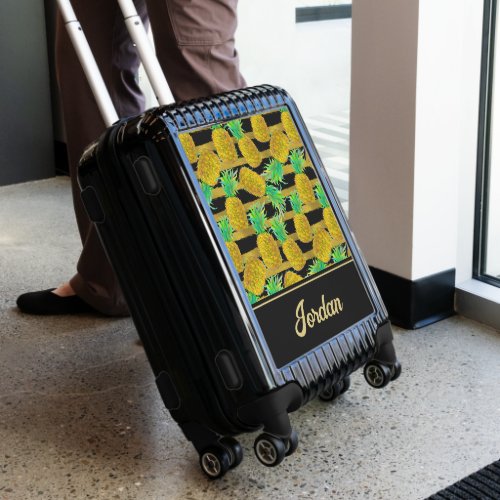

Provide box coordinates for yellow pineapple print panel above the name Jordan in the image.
[180,107,352,306]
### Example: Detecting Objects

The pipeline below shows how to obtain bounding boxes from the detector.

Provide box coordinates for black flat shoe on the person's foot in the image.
[17,288,97,315]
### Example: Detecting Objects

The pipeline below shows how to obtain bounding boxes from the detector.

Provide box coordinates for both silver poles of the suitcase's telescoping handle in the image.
[57,0,170,127]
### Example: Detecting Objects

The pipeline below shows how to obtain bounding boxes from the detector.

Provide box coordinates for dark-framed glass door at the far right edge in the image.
[474,0,500,287]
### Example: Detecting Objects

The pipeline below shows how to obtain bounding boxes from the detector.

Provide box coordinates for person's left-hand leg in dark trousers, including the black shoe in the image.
[18,0,147,315]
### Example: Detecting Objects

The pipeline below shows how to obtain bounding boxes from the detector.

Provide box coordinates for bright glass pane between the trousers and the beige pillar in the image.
[236,0,351,210]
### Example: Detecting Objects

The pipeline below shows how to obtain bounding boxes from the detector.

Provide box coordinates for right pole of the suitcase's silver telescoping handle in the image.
[118,0,171,105]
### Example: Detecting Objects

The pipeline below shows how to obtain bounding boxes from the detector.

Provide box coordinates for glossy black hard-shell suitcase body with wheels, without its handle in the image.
[79,85,401,477]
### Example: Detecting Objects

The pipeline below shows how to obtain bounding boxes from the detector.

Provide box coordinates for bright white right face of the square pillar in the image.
[411,0,464,280]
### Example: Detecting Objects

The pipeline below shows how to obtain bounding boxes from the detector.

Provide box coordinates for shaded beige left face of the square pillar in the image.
[349,0,418,279]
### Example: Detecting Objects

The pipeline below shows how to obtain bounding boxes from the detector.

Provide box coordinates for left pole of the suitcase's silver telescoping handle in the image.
[57,0,118,127]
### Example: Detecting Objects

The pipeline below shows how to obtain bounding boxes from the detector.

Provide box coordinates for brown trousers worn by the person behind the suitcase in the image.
[56,0,245,316]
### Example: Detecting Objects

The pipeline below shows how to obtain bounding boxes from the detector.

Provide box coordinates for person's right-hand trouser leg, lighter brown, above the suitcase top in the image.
[146,0,245,101]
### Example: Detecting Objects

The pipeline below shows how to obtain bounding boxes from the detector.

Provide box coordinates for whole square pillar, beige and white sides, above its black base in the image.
[349,0,482,282]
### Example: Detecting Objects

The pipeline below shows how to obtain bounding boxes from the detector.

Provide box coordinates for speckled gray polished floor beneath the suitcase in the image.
[0,178,500,500]
